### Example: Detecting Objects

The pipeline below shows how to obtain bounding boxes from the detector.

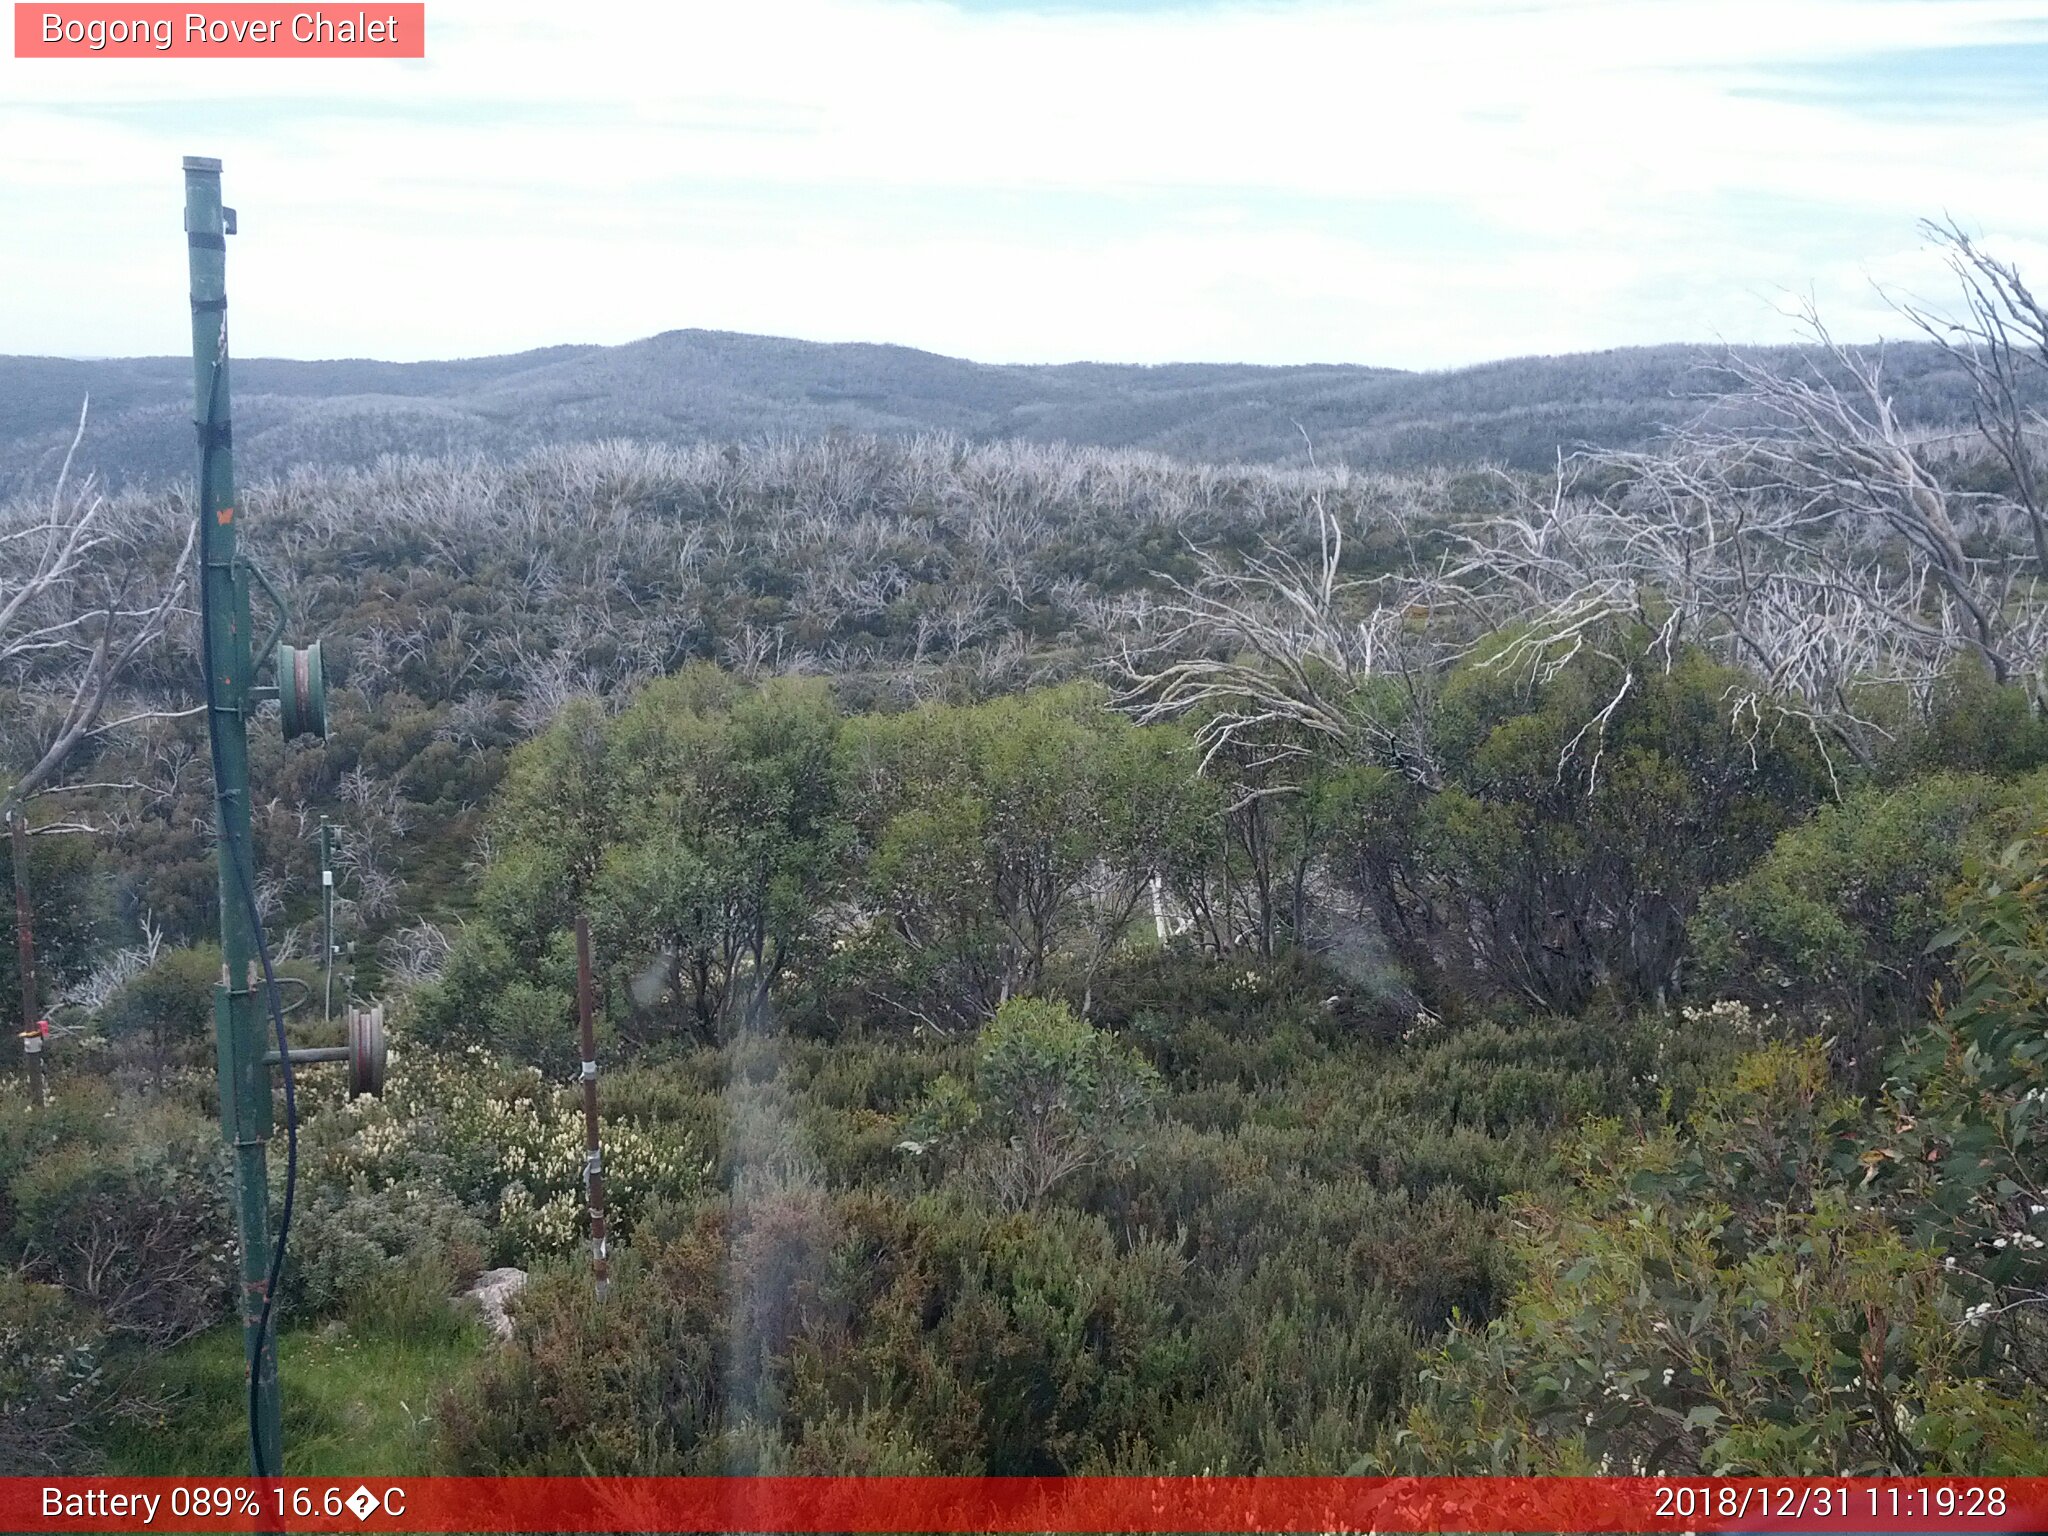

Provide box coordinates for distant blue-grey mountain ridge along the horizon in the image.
[0,330,2015,489]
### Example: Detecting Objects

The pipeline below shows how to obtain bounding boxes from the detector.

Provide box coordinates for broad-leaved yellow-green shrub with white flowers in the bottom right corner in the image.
[1376,838,2048,1475]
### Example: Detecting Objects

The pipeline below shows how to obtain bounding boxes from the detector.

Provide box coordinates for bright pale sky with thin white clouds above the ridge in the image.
[0,0,2048,369]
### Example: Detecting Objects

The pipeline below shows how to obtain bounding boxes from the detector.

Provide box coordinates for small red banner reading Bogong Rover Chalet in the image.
[14,0,426,59]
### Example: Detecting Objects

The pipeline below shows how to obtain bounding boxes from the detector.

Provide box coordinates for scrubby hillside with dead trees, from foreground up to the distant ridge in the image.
[0,225,2048,1475]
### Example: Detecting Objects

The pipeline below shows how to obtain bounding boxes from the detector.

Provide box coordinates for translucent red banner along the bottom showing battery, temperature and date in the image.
[0,1477,2048,1536]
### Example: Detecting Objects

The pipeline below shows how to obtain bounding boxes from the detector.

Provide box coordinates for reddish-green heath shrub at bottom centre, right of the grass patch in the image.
[444,1188,1236,1475]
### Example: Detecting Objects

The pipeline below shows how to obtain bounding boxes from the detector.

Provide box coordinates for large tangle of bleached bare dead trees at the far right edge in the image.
[1448,274,2048,774]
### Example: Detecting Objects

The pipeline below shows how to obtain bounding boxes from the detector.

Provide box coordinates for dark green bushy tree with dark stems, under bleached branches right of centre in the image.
[1339,651,1825,1012]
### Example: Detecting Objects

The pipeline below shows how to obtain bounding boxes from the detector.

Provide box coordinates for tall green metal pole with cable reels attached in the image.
[184,156,283,1477]
